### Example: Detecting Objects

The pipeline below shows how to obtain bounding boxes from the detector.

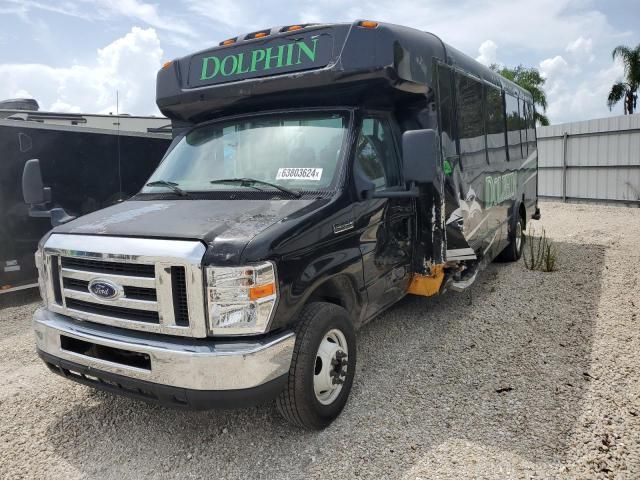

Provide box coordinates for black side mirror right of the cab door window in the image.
[402,130,439,184]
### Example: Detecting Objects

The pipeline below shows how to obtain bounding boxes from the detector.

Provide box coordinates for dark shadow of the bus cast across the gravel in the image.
[48,243,605,478]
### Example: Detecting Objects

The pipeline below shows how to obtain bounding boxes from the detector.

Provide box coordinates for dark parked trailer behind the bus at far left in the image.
[0,106,171,293]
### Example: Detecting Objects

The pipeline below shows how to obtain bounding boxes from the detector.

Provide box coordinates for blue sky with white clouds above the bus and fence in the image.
[0,0,640,124]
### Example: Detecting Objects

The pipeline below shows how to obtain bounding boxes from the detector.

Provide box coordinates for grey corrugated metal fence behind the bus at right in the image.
[537,115,640,206]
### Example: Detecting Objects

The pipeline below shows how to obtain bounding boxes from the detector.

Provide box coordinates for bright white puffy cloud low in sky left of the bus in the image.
[0,27,163,114]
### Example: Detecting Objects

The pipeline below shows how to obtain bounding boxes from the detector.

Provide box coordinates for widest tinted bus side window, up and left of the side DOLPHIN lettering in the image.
[456,74,486,168]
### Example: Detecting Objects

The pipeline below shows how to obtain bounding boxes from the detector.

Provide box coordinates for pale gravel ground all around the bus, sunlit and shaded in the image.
[0,203,640,479]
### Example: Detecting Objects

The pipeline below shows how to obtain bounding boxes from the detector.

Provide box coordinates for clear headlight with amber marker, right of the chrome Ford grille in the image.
[205,262,278,335]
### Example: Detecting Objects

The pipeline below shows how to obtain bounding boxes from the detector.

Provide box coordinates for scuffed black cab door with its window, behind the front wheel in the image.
[354,115,414,318]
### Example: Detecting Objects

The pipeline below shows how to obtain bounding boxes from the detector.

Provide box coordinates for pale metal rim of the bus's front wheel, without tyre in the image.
[313,328,349,405]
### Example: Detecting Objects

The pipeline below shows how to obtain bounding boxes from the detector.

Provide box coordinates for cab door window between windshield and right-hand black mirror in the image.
[356,118,400,190]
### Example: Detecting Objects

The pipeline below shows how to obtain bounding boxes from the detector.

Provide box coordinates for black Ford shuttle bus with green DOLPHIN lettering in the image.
[24,21,540,429]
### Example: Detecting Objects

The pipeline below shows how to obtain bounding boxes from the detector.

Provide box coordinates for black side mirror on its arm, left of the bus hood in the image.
[22,158,75,227]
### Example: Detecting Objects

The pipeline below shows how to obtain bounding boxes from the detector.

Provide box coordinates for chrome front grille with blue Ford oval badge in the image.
[43,234,207,338]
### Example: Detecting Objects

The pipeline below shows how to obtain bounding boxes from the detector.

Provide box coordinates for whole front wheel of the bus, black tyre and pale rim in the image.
[276,302,356,430]
